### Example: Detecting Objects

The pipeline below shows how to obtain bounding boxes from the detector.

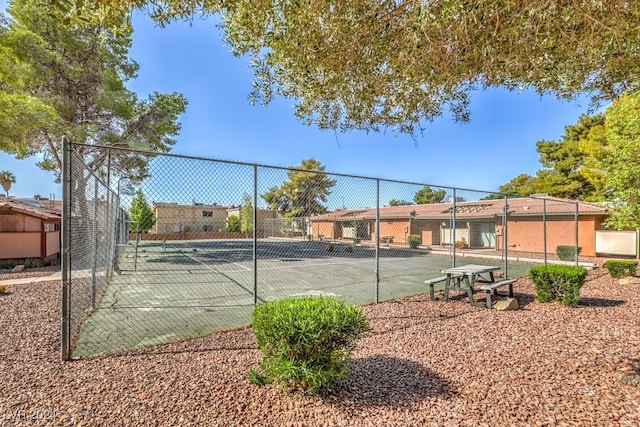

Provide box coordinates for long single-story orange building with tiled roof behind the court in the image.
[311,196,609,256]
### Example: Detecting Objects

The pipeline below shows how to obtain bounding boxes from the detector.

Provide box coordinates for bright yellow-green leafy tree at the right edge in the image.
[603,92,640,229]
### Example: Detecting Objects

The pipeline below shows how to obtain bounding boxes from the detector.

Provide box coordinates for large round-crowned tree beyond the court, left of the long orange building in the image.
[261,159,336,218]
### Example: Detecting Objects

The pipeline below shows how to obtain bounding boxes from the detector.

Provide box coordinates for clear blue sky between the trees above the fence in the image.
[0,6,600,199]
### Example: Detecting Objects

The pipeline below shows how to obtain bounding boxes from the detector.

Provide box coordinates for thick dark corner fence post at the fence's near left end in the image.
[60,136,71,361]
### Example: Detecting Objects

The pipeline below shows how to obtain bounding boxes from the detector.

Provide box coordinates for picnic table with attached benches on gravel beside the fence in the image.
[425,264,516,308]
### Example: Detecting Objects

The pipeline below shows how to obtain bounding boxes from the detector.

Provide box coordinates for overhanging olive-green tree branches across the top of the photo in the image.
[61,0,640,133]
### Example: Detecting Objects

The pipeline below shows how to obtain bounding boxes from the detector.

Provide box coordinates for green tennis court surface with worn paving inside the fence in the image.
[74,239,528,357]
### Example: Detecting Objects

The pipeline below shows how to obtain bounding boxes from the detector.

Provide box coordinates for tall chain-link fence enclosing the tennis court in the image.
[62,144,577,359]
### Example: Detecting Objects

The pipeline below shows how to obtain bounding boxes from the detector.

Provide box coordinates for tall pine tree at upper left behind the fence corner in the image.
[0,0,187,184]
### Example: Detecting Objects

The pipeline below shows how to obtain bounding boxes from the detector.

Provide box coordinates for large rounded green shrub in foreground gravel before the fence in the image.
[249,296,369,394]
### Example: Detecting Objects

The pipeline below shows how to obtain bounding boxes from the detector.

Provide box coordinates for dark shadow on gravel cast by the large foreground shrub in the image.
[332,355,455,408]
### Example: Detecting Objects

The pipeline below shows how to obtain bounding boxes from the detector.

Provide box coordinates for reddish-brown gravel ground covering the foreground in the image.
[0,269,640,426]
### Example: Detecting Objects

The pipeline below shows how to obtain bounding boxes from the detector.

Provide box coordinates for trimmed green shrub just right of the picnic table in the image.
[529,265,587,306]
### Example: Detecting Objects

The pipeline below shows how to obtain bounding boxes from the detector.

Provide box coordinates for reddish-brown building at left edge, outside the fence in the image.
[0,198,62,259]
